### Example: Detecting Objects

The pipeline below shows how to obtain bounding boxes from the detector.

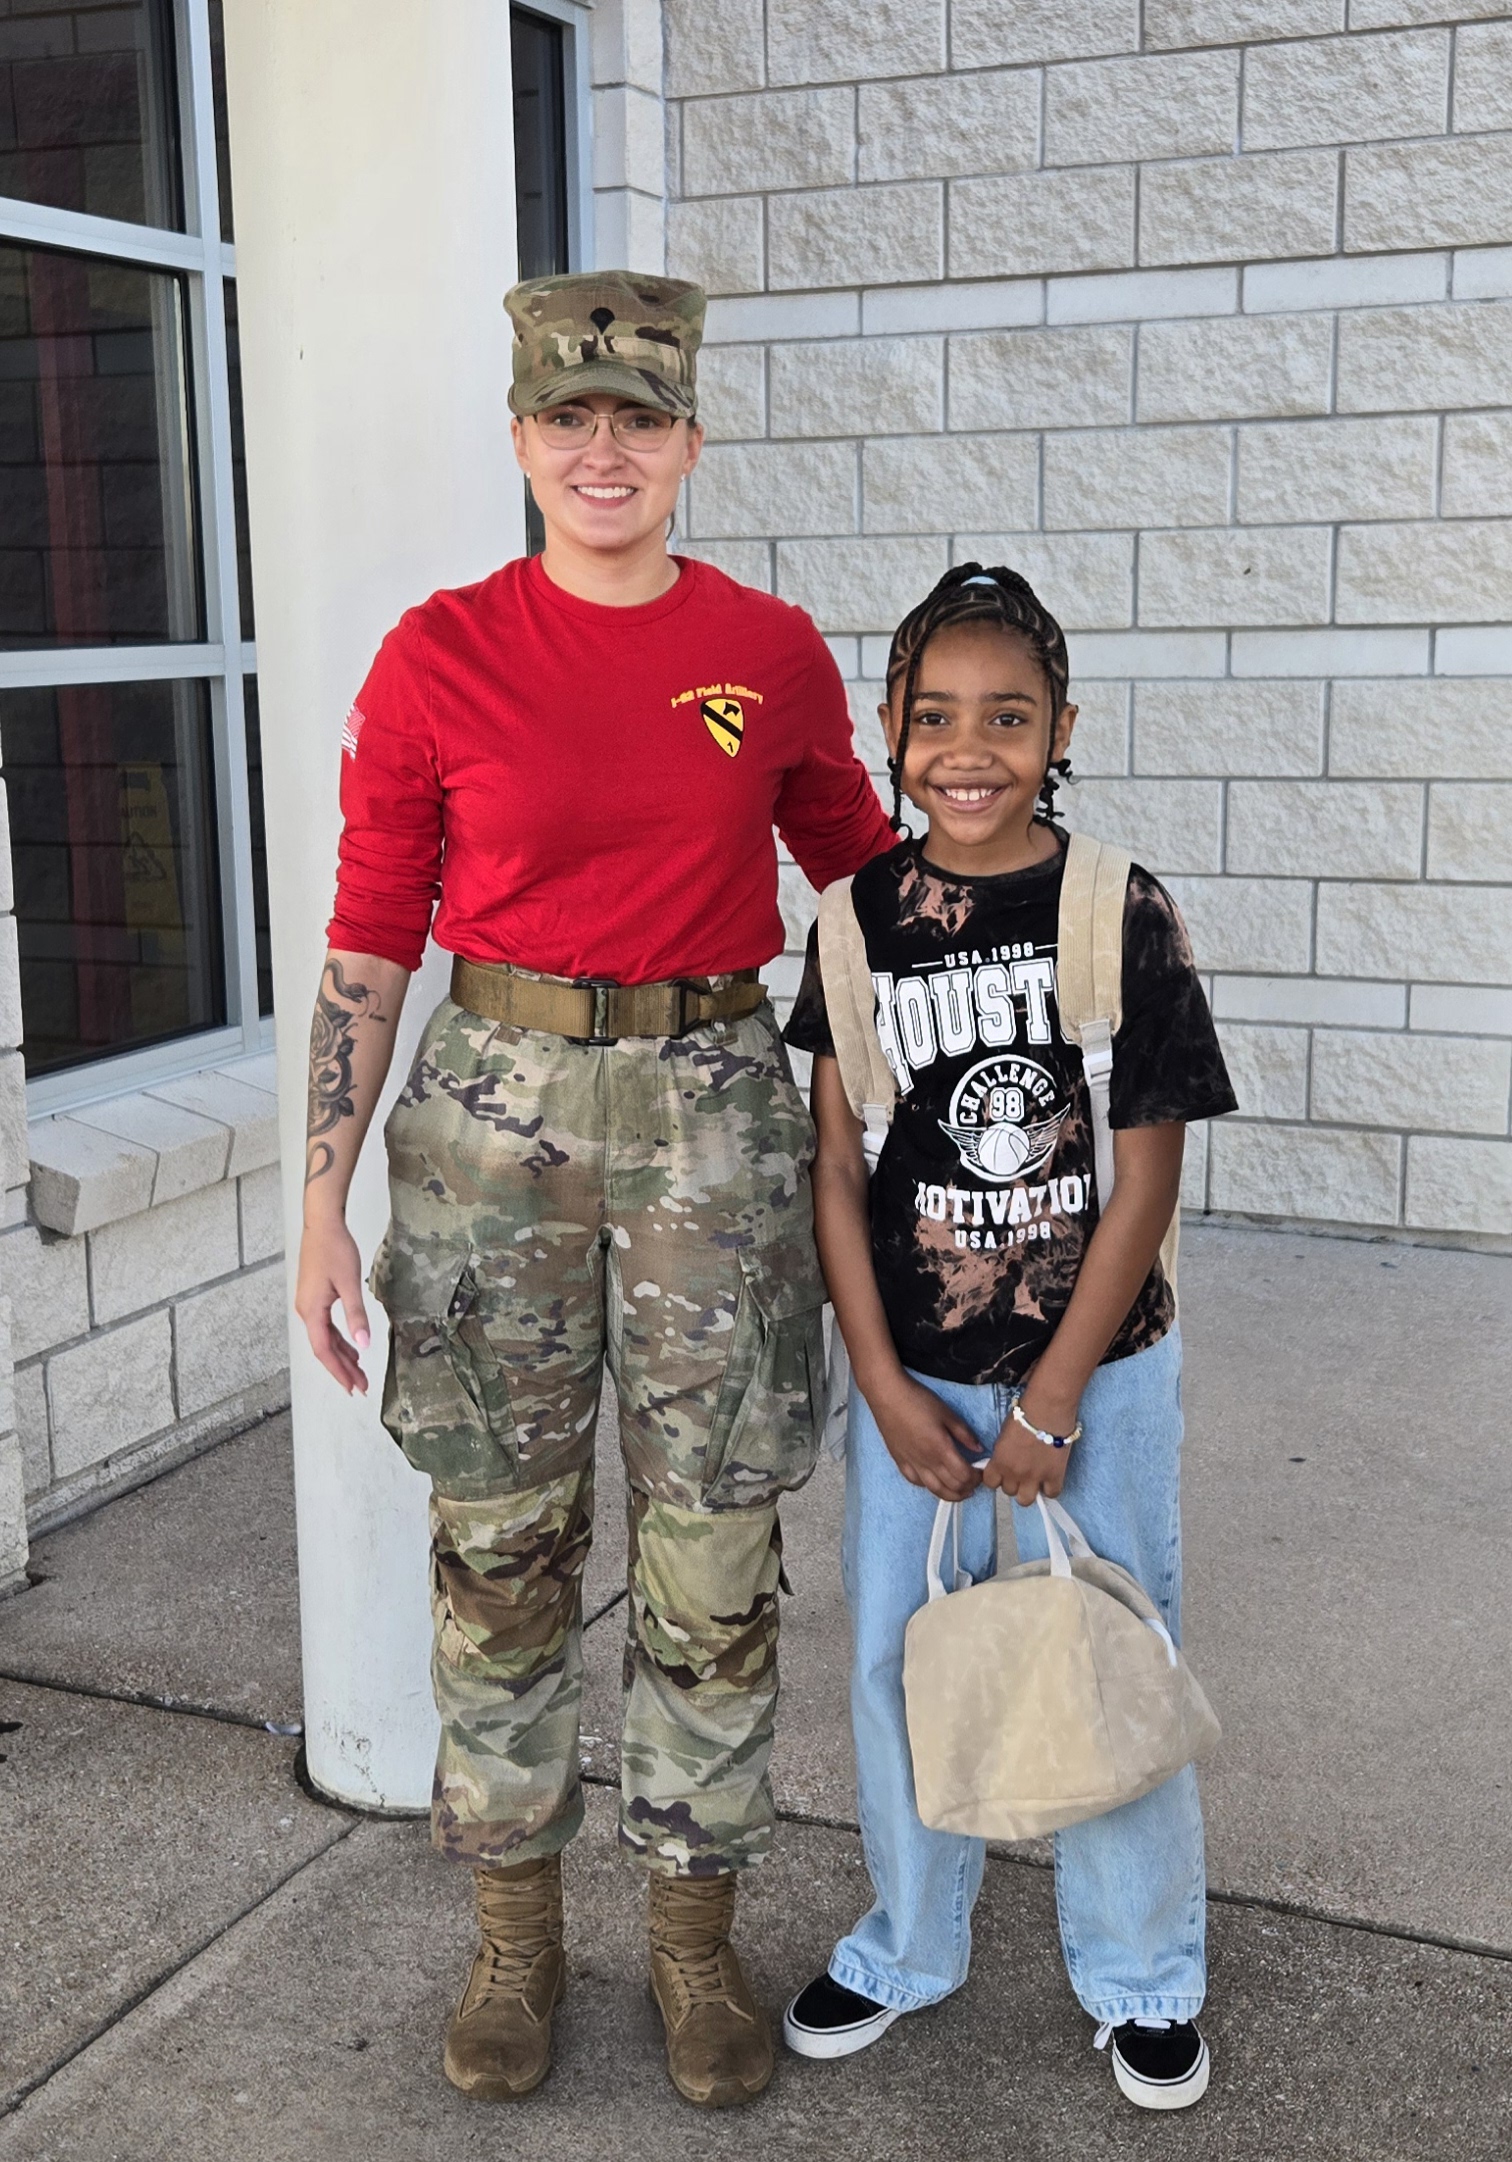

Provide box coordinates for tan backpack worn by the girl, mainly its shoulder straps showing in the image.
[820,832,1181,1288]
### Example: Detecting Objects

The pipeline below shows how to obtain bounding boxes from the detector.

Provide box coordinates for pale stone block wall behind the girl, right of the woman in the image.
[664,0,1512,1239]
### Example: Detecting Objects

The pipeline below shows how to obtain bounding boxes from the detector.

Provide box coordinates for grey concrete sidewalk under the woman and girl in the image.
[0,1228,1512,2162]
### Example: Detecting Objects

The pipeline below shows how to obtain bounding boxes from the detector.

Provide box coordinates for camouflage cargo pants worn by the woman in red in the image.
[372,999,824,1874]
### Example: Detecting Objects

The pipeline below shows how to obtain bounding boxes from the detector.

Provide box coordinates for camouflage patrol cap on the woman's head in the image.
[504,270,705,419]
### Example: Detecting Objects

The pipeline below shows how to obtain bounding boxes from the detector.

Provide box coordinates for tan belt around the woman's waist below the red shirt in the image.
[452,956,766,1044]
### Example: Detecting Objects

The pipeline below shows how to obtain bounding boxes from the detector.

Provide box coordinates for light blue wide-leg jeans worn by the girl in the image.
[828,1330,1207,2021]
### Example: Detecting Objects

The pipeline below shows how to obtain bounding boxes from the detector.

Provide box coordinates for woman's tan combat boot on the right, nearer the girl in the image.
[651,1872,772,2110]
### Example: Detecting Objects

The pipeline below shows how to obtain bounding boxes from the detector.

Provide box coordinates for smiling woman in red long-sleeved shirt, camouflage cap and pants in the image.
[296,270,893,2106]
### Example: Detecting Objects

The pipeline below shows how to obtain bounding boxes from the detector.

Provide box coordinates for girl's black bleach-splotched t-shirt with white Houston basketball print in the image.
[783,839,1237,1382]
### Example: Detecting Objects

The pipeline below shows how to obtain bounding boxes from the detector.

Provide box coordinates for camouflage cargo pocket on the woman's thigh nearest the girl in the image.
[703,1239,824,1509]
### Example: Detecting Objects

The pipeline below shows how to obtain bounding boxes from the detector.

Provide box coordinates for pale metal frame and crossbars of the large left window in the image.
[0,0,264,1118]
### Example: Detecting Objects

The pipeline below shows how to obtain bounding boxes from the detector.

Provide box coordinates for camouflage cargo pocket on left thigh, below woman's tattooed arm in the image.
[368,1230,519,1494]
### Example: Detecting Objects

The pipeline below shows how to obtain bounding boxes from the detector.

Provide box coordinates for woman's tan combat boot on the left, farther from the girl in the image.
[441,1855,567,2101]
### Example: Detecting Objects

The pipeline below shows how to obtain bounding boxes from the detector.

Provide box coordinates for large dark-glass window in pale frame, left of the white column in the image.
[0,0,273,1081]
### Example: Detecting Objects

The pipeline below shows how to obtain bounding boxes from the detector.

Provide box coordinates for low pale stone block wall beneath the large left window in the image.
[0,1053,288,1547]
